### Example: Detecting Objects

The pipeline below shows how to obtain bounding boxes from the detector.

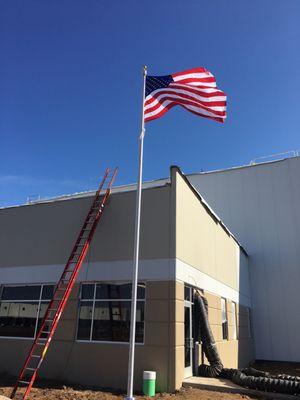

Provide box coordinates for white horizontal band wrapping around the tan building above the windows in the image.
[0,259,251,306]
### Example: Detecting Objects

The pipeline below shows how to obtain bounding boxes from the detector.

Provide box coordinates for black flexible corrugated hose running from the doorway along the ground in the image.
[194,293,300,395]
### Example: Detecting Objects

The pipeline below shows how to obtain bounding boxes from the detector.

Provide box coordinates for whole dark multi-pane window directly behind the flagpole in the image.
[77,283,145,343]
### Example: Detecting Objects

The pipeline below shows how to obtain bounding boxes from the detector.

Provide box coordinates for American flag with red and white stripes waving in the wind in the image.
[144,67,226,122]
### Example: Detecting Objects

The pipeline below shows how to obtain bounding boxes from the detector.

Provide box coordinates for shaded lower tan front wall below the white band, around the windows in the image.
[0,282,180,391]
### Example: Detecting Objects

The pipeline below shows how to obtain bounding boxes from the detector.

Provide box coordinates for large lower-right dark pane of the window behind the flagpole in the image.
[92,301,144,343]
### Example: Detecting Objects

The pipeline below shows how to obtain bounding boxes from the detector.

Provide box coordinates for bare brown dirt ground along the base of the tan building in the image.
[0,375,265,400]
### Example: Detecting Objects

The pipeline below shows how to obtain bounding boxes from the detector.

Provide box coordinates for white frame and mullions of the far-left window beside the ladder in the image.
[0,282,56,340]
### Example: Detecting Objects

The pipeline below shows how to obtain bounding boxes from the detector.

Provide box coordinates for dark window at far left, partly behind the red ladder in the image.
[0,285,54,339]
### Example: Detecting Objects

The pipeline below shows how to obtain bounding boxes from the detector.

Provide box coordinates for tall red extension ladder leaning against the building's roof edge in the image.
[10,168,118,400]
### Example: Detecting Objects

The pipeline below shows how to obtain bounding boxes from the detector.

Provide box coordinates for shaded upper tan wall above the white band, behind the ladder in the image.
[0,186,174,267]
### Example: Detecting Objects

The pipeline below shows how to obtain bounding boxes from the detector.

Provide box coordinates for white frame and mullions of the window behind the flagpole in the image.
[75,280,147,346]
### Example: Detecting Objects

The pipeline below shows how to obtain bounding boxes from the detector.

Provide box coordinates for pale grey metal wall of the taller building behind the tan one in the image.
[189,157,300,361]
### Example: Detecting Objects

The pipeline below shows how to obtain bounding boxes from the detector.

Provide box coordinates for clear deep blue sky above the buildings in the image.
[0,0,300,206]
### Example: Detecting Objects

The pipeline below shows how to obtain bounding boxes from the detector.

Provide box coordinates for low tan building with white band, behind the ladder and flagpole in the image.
[0,167,254,391]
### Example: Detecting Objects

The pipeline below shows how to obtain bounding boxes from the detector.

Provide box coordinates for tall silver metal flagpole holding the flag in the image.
[126,66,147,400]
